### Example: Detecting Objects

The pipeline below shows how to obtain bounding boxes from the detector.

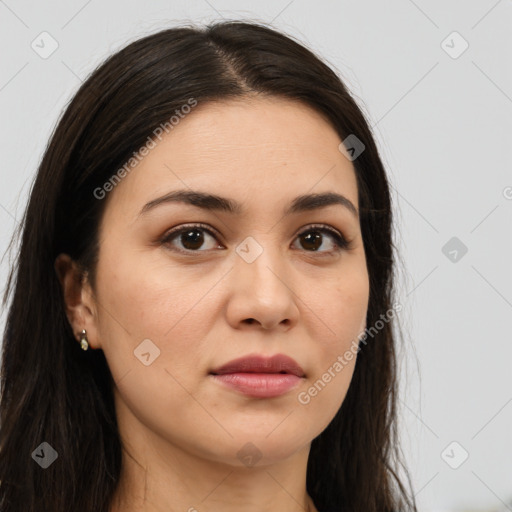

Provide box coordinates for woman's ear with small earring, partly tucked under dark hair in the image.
[54,253,99,349]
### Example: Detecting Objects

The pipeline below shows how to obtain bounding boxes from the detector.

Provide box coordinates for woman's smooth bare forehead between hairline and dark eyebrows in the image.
[101,98,357,219]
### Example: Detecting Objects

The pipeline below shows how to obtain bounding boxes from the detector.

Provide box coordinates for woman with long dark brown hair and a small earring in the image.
[0,22,415,512]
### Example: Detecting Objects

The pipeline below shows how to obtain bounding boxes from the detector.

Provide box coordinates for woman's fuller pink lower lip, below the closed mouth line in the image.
[212,373,301,398]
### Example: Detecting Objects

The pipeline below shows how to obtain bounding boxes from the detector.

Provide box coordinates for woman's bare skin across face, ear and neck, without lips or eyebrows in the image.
[55,97,369,512]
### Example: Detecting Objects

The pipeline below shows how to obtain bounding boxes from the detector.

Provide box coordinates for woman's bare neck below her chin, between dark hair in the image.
[110,436,318,512]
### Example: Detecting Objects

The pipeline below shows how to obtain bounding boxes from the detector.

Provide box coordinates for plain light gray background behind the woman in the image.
[0,0,512,511]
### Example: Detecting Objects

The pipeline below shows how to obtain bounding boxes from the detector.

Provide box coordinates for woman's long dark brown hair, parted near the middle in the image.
[0,21,416,512]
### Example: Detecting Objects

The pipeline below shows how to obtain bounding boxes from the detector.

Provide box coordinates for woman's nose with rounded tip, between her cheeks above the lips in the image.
[227,241,299,331]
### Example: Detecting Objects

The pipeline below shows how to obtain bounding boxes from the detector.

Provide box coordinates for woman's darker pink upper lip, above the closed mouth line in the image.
[211,354,304,377]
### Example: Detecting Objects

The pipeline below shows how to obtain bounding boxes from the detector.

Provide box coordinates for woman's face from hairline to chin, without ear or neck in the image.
[85,99,369,466]
